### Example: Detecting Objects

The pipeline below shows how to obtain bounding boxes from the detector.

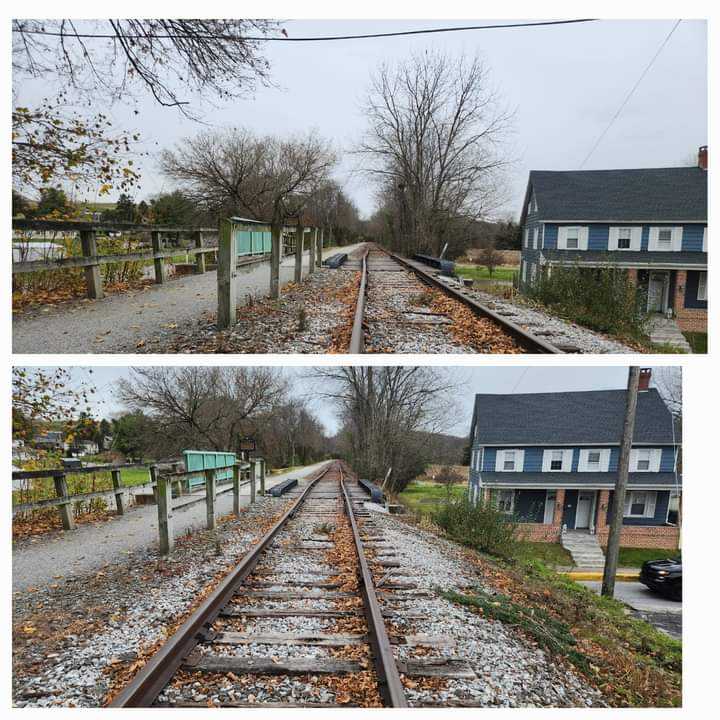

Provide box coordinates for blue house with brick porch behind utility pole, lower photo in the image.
[469,374,681,548]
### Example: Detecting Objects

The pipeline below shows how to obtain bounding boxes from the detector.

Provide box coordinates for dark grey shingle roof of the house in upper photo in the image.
[523,167,707,222]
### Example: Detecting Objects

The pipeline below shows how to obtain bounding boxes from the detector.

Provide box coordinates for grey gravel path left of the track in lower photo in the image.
[12,463,324,592]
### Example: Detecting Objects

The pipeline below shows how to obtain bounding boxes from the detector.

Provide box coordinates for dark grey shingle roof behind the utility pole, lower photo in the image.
[473,388,679,445]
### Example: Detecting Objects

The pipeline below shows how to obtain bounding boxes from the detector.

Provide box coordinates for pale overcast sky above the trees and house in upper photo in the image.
[14,20,707,217]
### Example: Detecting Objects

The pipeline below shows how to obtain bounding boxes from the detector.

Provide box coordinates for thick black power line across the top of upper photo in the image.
[13,18,597,42]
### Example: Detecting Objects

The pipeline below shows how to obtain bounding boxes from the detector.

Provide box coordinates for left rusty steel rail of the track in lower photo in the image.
[108,463,336,708]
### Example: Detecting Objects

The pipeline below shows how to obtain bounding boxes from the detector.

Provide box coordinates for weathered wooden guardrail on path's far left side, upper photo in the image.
[12,218,218,299]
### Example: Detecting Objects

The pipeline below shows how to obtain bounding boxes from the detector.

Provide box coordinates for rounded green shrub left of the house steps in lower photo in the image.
[432,496,517,558]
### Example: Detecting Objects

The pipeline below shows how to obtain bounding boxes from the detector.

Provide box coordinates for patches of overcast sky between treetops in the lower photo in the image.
[19,366,667,437]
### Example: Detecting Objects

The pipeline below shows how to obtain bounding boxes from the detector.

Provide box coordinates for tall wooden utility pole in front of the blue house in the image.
[602,366,640,597]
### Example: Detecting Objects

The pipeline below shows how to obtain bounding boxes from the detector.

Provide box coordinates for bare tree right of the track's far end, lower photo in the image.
[314,366,453,492]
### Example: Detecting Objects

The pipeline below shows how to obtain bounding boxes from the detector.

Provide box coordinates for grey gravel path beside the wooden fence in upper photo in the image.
[13,245,366,354]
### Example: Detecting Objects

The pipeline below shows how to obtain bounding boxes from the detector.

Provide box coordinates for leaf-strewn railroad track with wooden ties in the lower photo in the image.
[110,462,414,707]
